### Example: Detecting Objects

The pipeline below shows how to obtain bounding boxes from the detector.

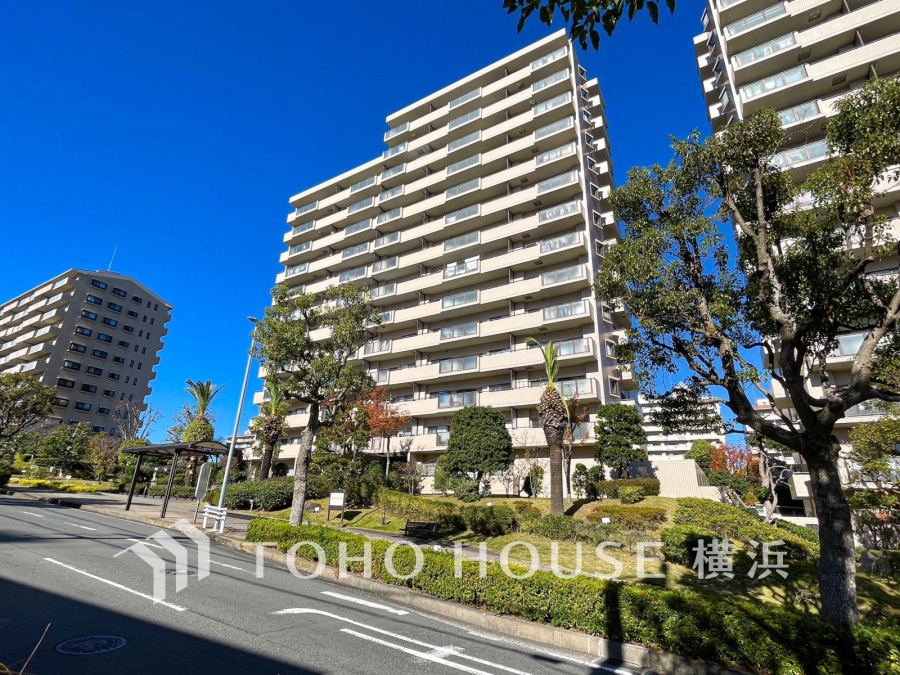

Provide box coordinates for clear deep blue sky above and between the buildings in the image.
[0,0,709,440]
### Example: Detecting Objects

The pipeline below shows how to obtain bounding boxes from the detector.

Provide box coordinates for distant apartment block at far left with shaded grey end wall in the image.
[0,269,172,436]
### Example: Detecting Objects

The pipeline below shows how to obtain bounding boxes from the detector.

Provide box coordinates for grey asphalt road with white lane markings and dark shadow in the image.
[0,497,630,675]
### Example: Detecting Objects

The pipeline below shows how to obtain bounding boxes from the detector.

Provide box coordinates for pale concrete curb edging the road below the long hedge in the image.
[0,488,749,675]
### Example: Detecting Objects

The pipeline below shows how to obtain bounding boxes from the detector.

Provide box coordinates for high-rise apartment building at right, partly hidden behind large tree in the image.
[694,0,900,516]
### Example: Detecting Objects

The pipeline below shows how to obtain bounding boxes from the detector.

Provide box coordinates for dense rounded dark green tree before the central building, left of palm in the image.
[444,405,512,486]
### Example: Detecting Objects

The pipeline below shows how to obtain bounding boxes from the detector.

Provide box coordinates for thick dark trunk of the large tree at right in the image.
[801,444,859,626]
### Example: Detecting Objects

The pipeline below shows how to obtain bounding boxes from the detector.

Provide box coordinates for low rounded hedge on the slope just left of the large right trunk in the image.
[674,497,819,560]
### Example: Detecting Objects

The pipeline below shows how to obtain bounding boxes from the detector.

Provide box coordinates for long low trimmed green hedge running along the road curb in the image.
[247,519,900,675]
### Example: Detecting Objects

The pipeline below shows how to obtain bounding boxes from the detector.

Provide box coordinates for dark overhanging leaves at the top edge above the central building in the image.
[503,0,675,49]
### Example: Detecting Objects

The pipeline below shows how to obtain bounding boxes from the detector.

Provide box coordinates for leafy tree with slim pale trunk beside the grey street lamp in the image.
[254,283,381,525]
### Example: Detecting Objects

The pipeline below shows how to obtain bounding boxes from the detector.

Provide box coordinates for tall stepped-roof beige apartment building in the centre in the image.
[255,31,634,490]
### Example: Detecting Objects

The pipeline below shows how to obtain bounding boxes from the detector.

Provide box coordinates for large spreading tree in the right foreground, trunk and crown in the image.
[598,80,900,625]
